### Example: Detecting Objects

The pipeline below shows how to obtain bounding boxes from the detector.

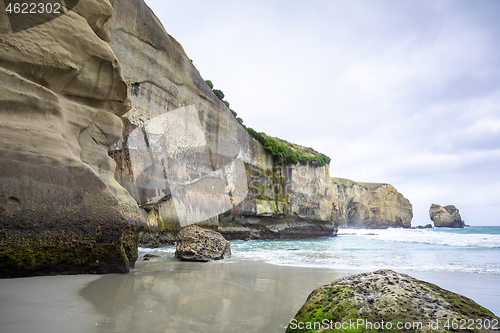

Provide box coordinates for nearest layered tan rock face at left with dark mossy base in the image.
[0,0,145,277]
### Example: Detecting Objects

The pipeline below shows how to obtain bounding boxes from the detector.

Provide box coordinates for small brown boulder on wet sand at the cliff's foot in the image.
[175,226,231,262]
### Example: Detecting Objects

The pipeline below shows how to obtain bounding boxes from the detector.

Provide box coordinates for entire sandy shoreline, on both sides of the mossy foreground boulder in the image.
[0,259,500,333]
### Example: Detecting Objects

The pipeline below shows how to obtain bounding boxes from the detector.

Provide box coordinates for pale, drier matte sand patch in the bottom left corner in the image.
[0,275,103,333]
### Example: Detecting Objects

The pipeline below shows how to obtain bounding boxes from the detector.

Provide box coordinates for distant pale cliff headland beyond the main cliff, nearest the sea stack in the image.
[332,178,413,228]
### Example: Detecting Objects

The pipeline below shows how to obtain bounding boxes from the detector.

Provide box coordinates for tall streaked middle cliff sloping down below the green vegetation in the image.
[110,0,336,245]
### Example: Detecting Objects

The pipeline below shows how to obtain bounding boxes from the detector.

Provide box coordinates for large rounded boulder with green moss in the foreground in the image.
[286,270,499,333]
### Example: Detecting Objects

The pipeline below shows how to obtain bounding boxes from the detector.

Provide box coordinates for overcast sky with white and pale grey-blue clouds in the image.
[142,0,500,226]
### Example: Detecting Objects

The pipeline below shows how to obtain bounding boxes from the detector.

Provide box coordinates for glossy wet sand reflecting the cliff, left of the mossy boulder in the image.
[81,258,348,333]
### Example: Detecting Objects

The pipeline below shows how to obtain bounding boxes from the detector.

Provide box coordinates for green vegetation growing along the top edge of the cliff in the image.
[205,80,331,166]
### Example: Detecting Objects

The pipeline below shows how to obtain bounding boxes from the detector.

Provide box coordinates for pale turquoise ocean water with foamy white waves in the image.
[141,227,500,274]
